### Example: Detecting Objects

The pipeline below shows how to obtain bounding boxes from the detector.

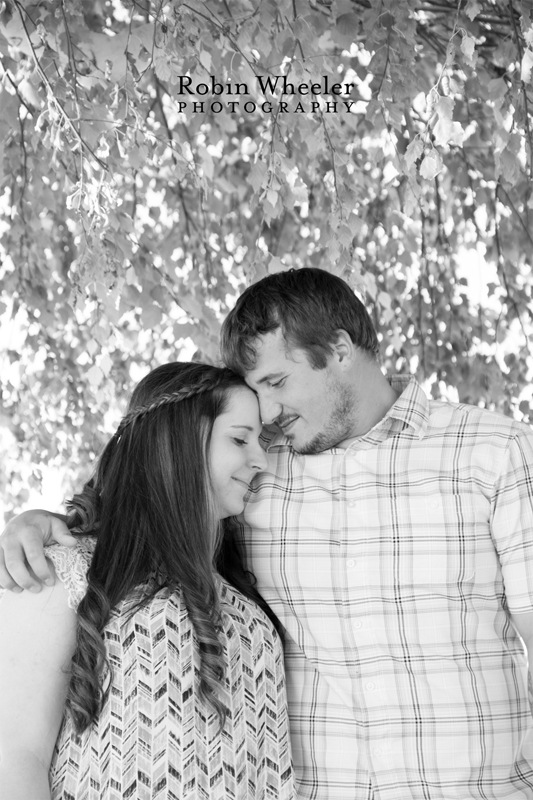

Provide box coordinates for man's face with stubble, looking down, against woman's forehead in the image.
[245,328,357,454]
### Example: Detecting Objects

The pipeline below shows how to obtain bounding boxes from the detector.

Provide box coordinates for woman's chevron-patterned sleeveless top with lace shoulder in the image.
[47,539,295,800]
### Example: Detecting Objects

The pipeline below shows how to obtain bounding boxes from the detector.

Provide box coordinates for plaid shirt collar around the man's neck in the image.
[261,375,429,451]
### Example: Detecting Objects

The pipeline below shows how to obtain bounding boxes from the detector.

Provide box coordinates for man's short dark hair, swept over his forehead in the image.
[221,267,379,375]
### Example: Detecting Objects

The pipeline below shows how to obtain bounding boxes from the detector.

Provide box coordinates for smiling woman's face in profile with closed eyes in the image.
[209,386,266,519]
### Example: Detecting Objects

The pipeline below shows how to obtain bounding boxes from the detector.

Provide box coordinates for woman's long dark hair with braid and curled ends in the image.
[67,362,272,732]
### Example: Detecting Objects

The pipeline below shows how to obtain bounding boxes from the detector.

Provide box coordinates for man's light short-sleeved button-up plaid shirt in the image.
[239,378,533,800]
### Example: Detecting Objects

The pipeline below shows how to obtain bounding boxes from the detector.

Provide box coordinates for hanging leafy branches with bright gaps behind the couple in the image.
[0,0,533,512]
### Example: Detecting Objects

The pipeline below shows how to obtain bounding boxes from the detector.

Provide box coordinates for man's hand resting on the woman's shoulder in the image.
[0,509,76,592]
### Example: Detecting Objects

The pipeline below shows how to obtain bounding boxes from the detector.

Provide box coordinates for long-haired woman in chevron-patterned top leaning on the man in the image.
[0,363,294,800]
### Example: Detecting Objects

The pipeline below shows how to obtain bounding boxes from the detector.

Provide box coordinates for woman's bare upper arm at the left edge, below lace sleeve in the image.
[0,581,76,800]
